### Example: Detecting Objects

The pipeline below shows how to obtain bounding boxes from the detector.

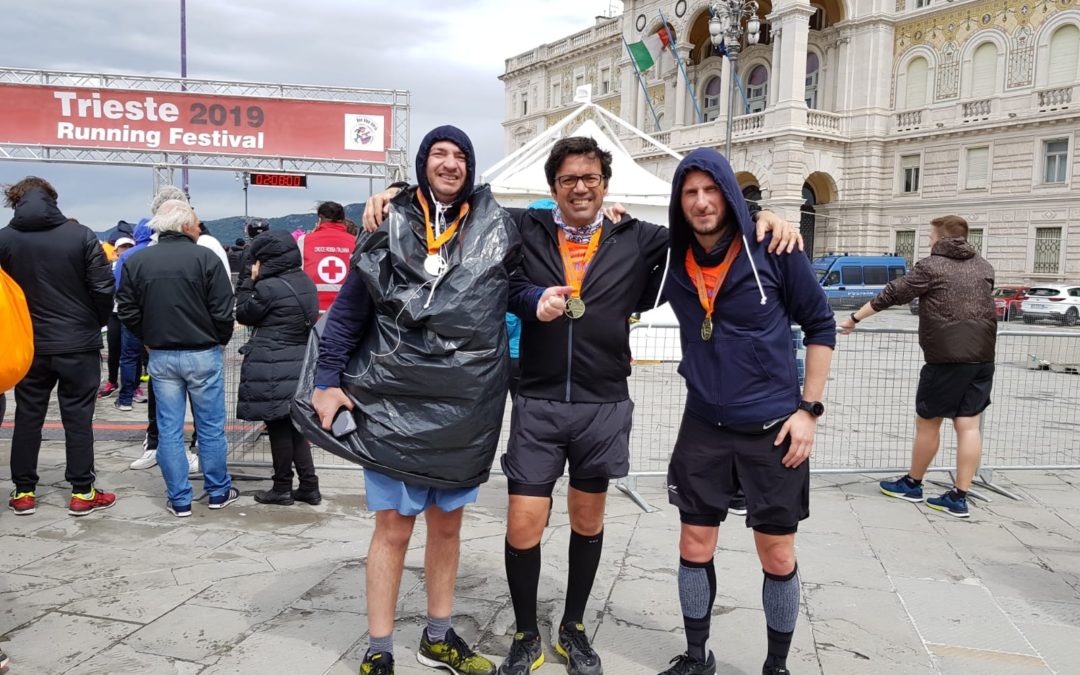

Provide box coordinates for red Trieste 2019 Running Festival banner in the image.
[0,84,391,162]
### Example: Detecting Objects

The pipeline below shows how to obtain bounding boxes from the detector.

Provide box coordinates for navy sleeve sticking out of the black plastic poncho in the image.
[315,270,375,387]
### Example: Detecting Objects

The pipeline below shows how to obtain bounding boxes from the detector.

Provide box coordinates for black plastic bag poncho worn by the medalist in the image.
[293,186,519,487]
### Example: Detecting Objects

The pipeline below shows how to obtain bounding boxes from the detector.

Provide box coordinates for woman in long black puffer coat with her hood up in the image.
[237,230,322,505]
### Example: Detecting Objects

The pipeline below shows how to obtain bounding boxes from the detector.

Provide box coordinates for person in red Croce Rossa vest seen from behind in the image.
[296,202,356,313]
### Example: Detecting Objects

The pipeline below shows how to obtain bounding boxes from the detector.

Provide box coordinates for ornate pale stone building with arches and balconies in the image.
[501,0,1080,281]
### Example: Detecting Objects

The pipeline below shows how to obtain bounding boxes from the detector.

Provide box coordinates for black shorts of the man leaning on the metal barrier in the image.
[915,363,994,419]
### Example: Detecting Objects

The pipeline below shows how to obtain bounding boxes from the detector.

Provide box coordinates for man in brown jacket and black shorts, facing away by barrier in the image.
[838,216,997,518]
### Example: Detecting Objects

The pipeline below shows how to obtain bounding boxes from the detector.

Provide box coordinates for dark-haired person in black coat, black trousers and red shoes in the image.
[0,176,116,516]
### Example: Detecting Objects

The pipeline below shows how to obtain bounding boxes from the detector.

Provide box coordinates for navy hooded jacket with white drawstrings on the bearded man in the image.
[664,148,836,427]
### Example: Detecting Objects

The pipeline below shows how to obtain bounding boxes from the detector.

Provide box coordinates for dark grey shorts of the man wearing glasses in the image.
[502,395,634,496]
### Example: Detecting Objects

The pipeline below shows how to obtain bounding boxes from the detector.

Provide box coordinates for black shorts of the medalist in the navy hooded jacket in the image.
[667,411,810,535]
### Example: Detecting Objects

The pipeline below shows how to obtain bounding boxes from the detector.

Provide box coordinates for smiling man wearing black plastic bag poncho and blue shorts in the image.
[312,126,518,675]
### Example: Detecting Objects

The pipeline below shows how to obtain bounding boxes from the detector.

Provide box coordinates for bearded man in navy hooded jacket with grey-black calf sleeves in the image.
[662,148,836,675]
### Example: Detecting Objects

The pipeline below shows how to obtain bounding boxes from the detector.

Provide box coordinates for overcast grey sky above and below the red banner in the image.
[0,0,611,229]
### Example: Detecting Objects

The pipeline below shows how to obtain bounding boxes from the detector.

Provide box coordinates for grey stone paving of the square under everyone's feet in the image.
[0,442,1080,675]
